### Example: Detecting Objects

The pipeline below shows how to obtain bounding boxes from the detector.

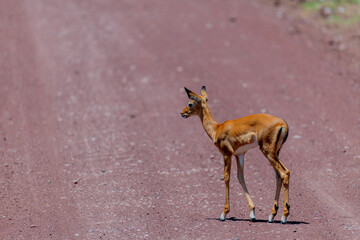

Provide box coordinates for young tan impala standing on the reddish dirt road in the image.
[181,86,290,223]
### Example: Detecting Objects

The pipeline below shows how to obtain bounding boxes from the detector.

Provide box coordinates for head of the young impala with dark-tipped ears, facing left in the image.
[180,86,208,118]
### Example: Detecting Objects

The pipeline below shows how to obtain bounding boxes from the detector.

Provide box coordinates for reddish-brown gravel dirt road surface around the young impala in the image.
[0,0,360,239]
